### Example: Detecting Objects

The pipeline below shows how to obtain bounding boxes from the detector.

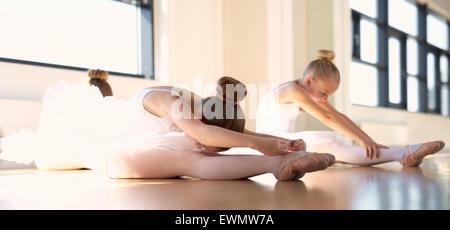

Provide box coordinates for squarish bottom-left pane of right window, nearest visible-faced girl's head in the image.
[350,62,378,106]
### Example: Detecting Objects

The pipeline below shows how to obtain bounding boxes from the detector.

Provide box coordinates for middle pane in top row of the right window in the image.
[388,0,418,36]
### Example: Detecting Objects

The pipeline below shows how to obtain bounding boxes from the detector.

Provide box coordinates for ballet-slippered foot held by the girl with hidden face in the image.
[274,152,335,181]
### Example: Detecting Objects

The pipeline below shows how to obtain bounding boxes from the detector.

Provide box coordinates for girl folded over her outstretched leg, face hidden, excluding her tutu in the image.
[108,77,334,180]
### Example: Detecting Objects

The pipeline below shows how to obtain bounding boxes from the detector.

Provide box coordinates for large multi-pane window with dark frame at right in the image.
[349,0,450,116]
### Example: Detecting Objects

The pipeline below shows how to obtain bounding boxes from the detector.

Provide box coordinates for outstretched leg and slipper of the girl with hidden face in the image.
[108,148,334,180]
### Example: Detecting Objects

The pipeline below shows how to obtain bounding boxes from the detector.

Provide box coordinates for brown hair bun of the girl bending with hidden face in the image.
[217,76,247,104]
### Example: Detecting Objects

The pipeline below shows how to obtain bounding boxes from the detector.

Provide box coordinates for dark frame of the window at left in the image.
[0,0,155,80]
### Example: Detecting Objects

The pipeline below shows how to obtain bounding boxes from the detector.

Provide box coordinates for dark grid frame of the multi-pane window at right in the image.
[351,0,450,116]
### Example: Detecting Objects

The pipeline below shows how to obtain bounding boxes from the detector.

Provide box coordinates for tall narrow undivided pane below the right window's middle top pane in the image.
[389,38,401,104]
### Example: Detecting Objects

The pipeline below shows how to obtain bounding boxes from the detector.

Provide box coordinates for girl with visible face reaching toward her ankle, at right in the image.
[257,50,444,167]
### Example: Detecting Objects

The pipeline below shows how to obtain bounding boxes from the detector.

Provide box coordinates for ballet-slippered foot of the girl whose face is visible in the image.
[401,141,445,168]
